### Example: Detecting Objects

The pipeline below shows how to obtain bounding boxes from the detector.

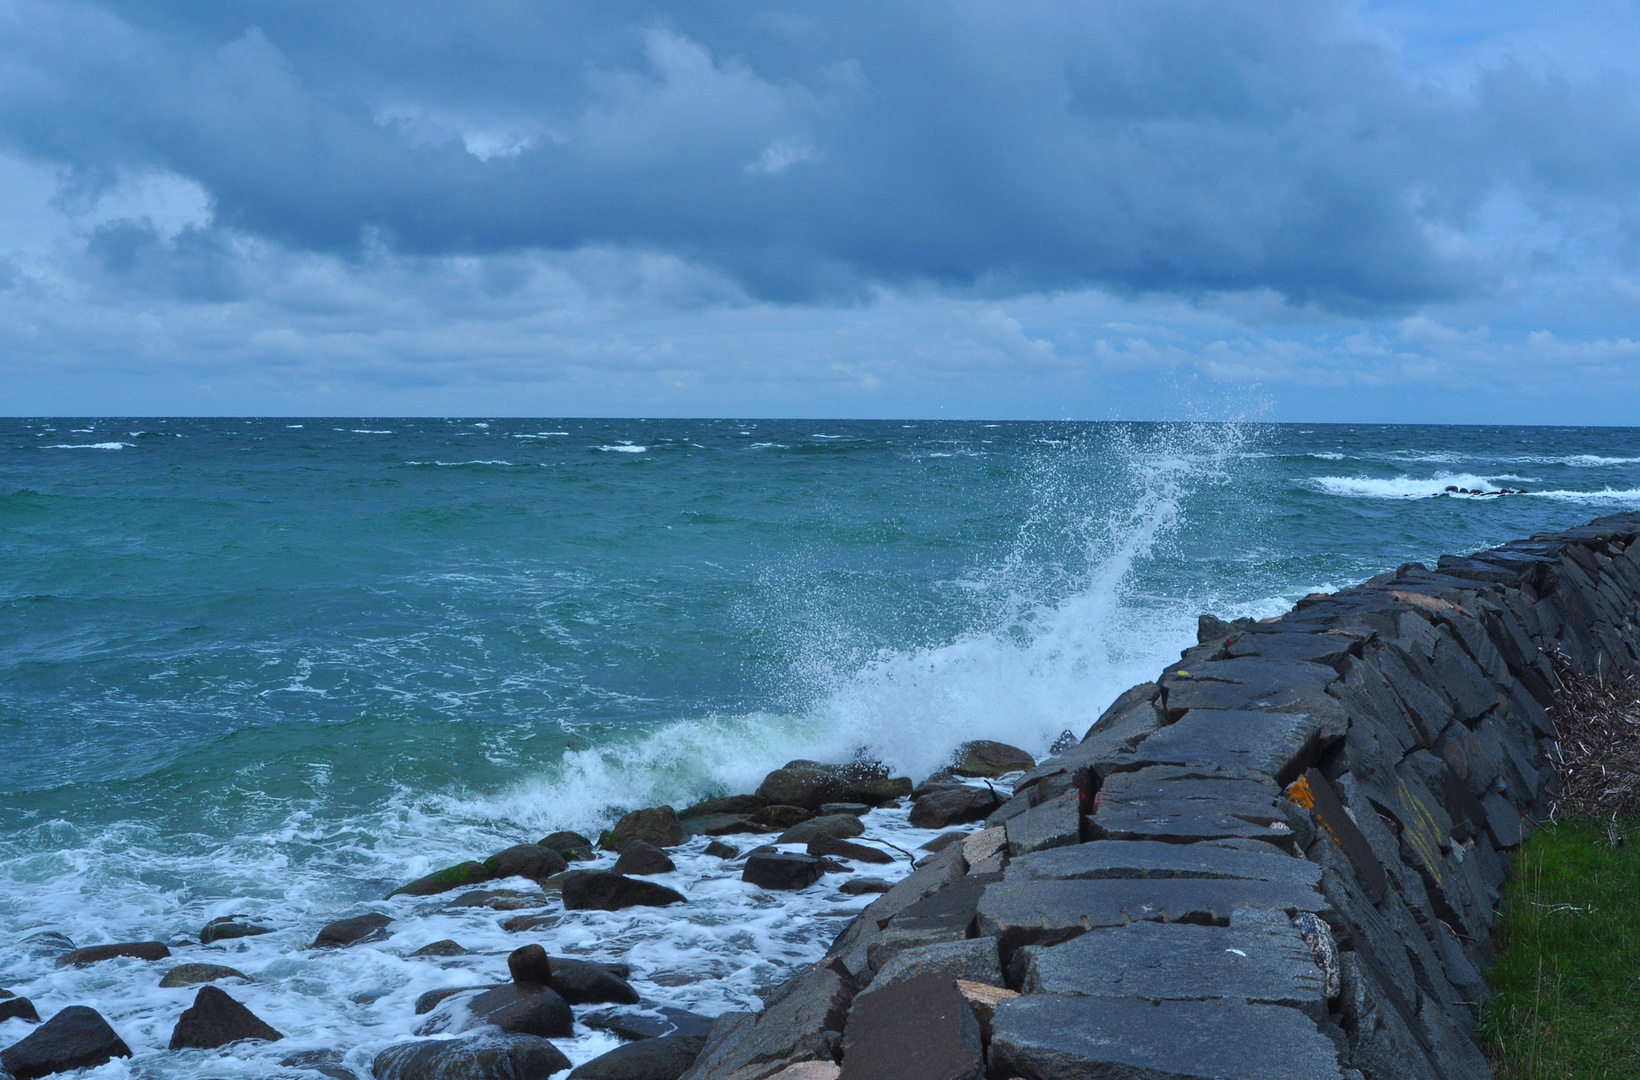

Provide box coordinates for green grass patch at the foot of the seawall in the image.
[1483,818,1640,1080]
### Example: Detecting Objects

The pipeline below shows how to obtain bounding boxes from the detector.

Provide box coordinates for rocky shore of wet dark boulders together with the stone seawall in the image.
[0,515,1640,1080]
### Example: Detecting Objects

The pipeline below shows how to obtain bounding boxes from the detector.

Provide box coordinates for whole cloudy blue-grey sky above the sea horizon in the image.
[0,0,1640,424]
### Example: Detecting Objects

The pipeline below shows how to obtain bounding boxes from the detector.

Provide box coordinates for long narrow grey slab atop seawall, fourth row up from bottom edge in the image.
[1004,841,1322,888]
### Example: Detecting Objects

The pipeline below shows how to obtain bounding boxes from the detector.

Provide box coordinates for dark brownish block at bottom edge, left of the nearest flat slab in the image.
[840,973,977,1080]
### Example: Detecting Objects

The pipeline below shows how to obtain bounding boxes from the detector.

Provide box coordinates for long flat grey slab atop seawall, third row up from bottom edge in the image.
[977,877,1328,955]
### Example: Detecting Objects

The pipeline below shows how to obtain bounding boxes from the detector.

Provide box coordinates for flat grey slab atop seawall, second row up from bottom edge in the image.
[1015,911,1327,1019]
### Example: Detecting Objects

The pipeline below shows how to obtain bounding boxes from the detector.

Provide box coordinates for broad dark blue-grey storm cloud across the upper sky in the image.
[0,0,1640,308]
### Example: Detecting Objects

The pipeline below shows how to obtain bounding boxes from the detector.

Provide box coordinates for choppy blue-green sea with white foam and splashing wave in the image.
[0,418,1640,1077]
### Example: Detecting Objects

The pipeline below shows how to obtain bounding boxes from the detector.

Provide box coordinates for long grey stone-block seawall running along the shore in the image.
[686,515,1640,1080]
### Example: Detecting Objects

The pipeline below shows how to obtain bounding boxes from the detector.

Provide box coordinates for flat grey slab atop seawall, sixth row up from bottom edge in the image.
[1133,711,1343,783]
